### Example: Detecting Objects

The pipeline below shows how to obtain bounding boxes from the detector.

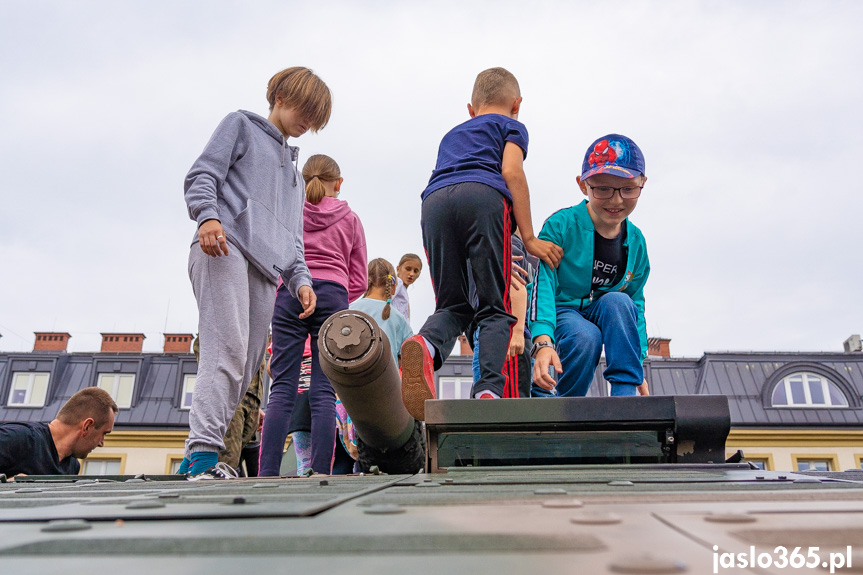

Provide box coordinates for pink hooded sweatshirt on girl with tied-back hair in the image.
[303,196,368,301]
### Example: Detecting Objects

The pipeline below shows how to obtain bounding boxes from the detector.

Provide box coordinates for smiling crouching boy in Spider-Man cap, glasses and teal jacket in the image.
[529,134,650,396]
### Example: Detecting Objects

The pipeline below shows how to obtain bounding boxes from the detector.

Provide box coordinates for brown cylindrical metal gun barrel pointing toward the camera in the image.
[318,310,414,452]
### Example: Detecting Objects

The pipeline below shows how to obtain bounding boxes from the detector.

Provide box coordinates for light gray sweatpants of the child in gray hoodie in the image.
[186,242,276,457]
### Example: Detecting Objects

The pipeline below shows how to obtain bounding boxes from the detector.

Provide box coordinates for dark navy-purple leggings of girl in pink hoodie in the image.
[259,280,348,477]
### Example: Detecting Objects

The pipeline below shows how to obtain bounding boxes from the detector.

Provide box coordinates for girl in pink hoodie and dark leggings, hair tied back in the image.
[260,155,368,477]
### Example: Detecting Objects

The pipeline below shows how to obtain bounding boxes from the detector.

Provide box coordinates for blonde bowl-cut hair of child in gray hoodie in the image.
[267,66,333,132]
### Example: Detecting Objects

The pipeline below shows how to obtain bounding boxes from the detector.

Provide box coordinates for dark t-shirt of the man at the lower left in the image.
[0,423,81,477]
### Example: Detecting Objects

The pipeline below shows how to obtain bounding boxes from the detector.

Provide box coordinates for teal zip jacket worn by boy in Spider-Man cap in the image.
[528,200,650,359]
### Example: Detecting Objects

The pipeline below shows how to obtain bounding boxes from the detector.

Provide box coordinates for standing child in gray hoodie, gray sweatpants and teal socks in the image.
[180,67,332,479]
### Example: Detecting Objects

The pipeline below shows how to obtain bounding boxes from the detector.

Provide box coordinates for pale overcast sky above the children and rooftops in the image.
[0,0,863,357]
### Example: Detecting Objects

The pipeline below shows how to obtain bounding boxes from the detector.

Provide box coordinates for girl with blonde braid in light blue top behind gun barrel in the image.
[351,258,414,361]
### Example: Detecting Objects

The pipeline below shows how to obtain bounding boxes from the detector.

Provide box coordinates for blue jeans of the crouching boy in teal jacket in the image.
[534,292,644,397]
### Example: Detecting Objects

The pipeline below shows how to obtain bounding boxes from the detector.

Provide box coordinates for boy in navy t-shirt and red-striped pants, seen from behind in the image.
[401,68,563,420]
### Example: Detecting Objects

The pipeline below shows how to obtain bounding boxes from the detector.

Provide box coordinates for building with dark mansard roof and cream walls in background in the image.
[5,332,863,475]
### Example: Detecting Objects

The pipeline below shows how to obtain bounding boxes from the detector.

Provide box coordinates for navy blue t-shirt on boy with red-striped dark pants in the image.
[422,114,528,201]
